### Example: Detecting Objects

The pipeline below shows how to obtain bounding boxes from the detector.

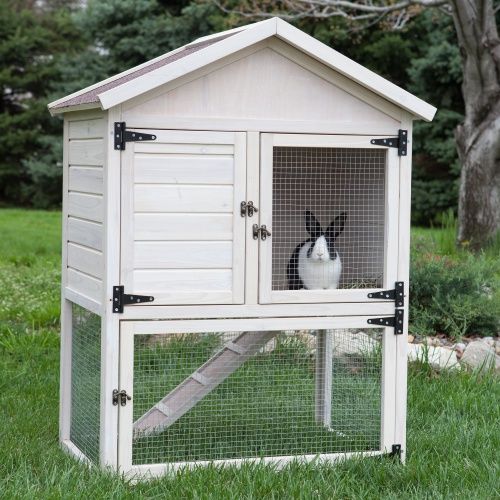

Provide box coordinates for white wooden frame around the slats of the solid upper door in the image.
[120,129,246,306]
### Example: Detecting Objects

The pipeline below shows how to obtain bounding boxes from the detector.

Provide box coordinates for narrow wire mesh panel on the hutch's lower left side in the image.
[70,304,101,463]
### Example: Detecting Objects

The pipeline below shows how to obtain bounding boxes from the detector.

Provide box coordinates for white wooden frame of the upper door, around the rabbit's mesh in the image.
[259,134,400,304]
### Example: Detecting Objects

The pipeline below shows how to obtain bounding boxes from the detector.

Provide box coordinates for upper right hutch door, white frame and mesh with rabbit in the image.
[259,134,399,303]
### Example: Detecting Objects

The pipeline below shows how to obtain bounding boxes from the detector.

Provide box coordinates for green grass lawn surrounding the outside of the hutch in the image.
[0,209,500,499]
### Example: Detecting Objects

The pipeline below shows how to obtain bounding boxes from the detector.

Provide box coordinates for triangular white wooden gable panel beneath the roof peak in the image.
[123,39,401,134]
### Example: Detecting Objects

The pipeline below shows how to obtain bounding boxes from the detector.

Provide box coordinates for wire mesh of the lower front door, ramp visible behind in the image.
[132,329,382,465]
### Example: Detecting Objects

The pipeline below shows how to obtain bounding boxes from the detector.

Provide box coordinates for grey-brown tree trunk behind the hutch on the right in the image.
[452,0,500,250]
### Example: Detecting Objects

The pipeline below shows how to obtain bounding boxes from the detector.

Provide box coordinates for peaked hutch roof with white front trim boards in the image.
[48,18,436,121]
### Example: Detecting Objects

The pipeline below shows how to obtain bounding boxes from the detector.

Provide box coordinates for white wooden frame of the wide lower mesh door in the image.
[118,316,398,479]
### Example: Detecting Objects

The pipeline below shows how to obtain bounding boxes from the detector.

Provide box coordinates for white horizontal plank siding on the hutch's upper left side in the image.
[63,112,106,305]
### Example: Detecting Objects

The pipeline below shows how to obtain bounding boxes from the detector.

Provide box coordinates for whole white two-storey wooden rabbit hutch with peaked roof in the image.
[49,18,435,478]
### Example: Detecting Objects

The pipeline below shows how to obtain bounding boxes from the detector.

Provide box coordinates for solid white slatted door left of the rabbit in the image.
[121,130,246,306]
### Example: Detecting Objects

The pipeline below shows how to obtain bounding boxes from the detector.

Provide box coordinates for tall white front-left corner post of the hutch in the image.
[100,107,121,469]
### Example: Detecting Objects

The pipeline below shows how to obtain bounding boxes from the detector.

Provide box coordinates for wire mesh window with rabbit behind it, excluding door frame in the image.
[272,147,386,290]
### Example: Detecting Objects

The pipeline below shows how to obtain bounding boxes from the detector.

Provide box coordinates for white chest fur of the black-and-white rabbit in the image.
[299,243,342,290]
